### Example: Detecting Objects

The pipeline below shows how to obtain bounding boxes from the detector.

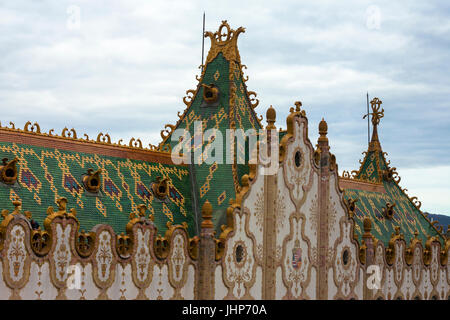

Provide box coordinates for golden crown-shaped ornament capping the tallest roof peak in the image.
[205,20,245,63]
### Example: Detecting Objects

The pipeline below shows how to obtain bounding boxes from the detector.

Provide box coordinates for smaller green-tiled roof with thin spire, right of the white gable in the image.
[340,98,444,245]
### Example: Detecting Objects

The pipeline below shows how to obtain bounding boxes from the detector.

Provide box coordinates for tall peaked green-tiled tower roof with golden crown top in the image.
[159,21,262,234]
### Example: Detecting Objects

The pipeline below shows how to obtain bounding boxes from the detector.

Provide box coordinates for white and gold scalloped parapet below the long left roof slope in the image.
[0,198,198,299]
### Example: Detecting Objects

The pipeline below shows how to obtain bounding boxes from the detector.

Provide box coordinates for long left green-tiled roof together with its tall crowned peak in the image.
[0,21,261,237]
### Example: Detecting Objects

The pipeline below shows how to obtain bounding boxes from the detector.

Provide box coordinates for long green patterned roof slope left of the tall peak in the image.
[0,128,195,235]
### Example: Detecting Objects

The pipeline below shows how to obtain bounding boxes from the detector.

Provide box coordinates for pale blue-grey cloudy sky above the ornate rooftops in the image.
[0,0,450,215]
